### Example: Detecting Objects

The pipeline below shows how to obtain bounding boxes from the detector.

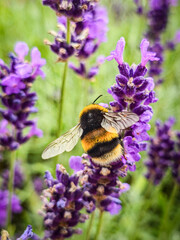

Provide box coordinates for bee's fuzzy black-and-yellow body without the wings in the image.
[80,104,122,164]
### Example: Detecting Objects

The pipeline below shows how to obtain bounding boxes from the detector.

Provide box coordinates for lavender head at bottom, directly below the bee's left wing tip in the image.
[42,164,88,239]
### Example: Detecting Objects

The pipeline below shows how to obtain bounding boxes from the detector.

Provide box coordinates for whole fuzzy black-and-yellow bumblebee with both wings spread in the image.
[42,103,139,166]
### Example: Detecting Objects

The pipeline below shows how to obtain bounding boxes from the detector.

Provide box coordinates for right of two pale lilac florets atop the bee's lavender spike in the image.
[140,39,159,66]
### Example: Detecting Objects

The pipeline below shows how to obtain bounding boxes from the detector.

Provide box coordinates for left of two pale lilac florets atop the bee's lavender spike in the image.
[106,37,125,65]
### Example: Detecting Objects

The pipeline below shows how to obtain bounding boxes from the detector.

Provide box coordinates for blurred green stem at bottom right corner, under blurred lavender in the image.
[158,183,179,239]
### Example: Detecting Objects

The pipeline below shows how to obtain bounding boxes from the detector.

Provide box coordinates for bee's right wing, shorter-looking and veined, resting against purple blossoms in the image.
[101,111,139,133]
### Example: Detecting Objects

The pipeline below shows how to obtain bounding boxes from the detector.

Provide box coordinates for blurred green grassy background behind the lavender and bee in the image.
[0,0,180,240]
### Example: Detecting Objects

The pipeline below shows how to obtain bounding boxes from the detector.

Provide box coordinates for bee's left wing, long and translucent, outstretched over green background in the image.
[42,123,83,159]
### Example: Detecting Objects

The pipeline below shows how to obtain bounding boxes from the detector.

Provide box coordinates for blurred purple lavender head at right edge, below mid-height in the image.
[145,118,180,185]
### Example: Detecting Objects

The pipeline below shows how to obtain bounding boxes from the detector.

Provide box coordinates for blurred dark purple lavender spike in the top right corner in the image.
[135,0,180,85]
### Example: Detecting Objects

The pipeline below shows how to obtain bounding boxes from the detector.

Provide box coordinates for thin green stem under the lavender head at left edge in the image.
[6,151,16,228]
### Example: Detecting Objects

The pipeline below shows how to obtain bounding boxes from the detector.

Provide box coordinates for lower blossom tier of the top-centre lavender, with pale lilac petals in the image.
[45,3,108,79]
